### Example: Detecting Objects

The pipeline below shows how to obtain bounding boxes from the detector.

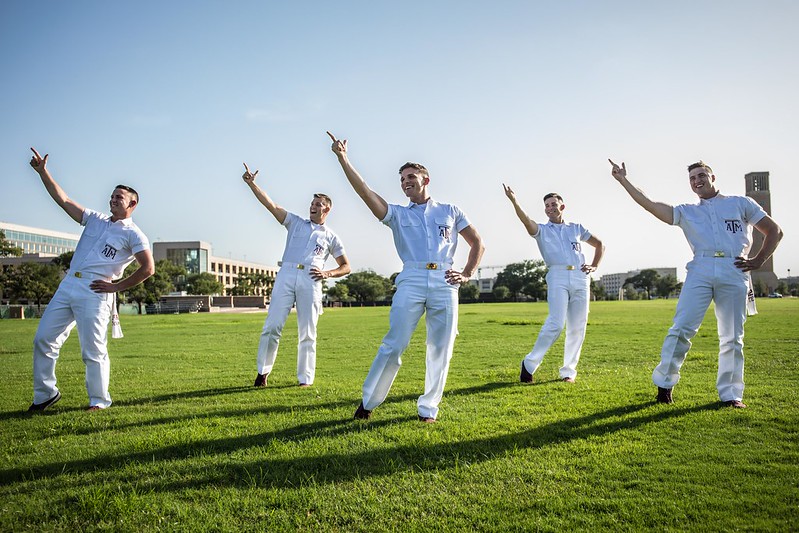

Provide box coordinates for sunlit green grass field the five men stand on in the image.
[0,299,799,532]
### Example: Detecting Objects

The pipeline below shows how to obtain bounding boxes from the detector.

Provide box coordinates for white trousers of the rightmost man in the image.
[652,257,749,402]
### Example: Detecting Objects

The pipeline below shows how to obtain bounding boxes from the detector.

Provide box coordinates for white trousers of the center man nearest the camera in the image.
[363,269,458,418]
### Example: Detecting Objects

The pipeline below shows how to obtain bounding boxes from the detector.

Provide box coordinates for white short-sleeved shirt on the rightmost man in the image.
[674,193,766,257]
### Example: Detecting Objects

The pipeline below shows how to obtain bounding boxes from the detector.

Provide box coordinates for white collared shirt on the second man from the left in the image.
[283,213,345,270]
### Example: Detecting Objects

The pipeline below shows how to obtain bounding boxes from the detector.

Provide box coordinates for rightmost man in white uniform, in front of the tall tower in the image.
[608,159,782,408]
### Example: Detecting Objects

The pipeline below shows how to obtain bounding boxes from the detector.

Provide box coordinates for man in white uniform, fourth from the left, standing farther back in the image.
[502,184,605,383]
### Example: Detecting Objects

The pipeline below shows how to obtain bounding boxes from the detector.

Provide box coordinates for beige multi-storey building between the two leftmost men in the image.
[153,241,277,295]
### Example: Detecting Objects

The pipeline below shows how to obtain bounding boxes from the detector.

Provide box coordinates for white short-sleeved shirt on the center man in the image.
[381,198,471,264]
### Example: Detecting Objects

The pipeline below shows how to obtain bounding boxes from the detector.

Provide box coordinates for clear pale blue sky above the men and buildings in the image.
[0,0,799,276]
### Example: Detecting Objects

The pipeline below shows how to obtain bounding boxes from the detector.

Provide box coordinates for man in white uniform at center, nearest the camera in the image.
[328,132,484,422]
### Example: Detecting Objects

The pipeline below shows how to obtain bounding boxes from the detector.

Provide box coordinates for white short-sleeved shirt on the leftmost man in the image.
[69,209,150,279]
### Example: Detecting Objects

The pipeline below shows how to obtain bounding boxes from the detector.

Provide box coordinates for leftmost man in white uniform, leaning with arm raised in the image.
[28,148,155,412]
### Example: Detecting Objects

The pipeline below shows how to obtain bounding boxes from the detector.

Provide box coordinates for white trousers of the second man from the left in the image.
[257,267,322,385]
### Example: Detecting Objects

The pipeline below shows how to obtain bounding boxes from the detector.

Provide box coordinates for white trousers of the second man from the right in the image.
[524,268,591,379]
